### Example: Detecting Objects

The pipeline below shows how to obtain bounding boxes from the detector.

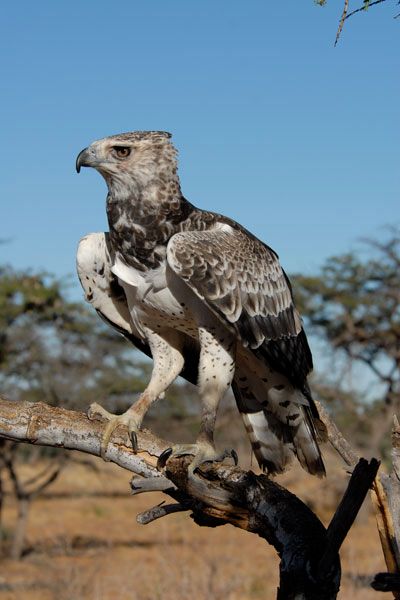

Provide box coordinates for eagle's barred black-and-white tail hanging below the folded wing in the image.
[232,378,326,477]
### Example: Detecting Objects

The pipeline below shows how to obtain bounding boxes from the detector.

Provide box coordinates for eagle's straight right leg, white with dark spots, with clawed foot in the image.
[158,321,237,477]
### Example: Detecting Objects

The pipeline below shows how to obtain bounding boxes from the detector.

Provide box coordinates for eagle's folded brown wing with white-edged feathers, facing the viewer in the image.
[167,224,312,387]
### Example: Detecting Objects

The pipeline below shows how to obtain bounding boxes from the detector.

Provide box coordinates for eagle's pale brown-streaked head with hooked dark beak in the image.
[76,131,177,190]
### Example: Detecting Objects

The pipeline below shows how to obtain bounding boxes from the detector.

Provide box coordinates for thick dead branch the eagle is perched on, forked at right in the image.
[0,399,379,600]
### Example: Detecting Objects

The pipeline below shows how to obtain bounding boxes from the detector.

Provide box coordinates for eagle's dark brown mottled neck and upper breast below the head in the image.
[107,177,194,270]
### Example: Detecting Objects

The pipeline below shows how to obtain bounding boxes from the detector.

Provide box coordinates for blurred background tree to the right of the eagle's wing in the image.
[294,228,400,458]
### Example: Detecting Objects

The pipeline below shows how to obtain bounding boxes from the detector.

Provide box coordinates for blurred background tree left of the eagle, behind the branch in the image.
[0,266,198,558]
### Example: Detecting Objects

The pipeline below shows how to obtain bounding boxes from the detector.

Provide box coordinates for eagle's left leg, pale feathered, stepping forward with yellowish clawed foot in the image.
[88,328,184,460]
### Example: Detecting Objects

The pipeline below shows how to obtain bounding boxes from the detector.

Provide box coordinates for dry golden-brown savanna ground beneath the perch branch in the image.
[0,436,387,600]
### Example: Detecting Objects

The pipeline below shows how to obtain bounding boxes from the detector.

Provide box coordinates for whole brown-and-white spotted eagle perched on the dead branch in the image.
[76,131,325,476]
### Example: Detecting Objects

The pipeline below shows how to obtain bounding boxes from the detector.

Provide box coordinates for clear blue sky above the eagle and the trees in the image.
[0,0,400,298]
